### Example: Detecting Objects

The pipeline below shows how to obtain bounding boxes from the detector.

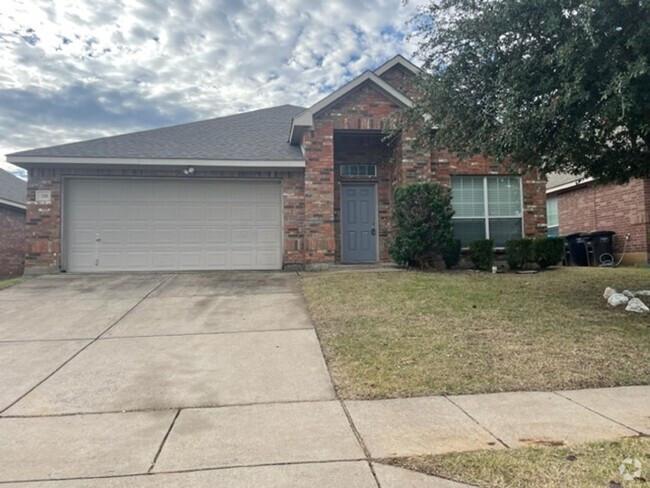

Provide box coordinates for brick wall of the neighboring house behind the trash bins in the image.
[557,179,650,253]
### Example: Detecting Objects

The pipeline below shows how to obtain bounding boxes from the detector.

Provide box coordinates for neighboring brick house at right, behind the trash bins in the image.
[546,173,650,264]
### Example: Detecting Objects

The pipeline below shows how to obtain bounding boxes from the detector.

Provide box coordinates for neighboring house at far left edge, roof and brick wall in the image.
[0,169,27,277]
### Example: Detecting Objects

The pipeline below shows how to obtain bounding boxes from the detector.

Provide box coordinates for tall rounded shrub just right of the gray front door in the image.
[389,183,454,268]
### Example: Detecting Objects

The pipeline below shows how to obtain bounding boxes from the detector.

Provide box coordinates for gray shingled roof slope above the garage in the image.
[8,105,305,161]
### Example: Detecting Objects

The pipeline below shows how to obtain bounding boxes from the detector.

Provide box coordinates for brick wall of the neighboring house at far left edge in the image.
[0,205,25,277]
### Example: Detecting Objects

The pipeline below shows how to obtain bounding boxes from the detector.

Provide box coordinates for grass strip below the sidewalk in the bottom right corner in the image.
[382,437,650,488]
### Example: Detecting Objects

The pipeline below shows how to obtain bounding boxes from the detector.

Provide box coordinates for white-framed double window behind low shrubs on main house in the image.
[451,176,523,247]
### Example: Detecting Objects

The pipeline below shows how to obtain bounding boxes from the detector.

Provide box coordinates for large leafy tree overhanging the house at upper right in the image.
[405,0,650,182]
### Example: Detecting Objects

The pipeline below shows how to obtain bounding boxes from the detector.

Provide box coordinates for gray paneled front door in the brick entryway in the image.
[341,185,377,263]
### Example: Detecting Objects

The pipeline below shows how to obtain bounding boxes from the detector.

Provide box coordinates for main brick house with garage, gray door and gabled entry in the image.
[8,56,546,273]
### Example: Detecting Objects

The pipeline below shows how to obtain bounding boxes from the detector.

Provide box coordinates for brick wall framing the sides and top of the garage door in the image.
[25,167,305,274]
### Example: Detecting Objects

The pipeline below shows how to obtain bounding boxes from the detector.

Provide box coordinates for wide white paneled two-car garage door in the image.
[63,178,282,272]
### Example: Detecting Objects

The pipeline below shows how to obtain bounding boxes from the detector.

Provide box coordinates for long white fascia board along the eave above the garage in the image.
[7,156,305,168]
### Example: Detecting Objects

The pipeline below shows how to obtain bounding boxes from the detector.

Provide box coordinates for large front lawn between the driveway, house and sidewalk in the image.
[302,268,650,398]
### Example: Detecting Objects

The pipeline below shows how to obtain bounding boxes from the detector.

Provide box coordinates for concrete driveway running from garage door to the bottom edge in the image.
[0,272,451,488]
